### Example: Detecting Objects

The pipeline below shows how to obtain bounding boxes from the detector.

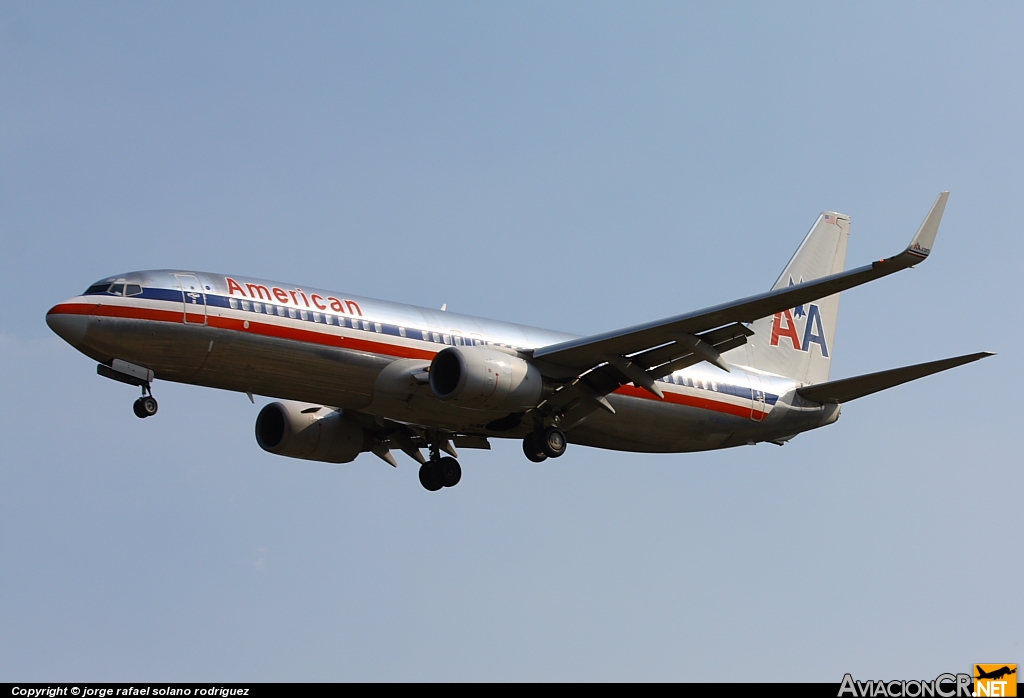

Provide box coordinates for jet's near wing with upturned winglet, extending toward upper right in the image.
[534,191,949,374]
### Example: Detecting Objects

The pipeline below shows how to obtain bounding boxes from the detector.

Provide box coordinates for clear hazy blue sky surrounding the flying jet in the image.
[0,0,1024,682]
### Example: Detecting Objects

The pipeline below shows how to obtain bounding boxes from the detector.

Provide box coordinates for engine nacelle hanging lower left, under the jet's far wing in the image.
[256,402,365,463]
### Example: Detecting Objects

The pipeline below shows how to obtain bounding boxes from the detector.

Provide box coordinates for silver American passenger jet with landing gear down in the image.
[46,191,992,491]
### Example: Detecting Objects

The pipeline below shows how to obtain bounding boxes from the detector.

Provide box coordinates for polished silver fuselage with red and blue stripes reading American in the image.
[47,270,839,452]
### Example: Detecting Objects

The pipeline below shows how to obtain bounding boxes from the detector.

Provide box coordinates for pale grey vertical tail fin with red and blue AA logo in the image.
[734,211,850,383]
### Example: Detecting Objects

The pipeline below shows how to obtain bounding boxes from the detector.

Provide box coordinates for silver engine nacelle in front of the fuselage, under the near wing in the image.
[430,347,544,411]
